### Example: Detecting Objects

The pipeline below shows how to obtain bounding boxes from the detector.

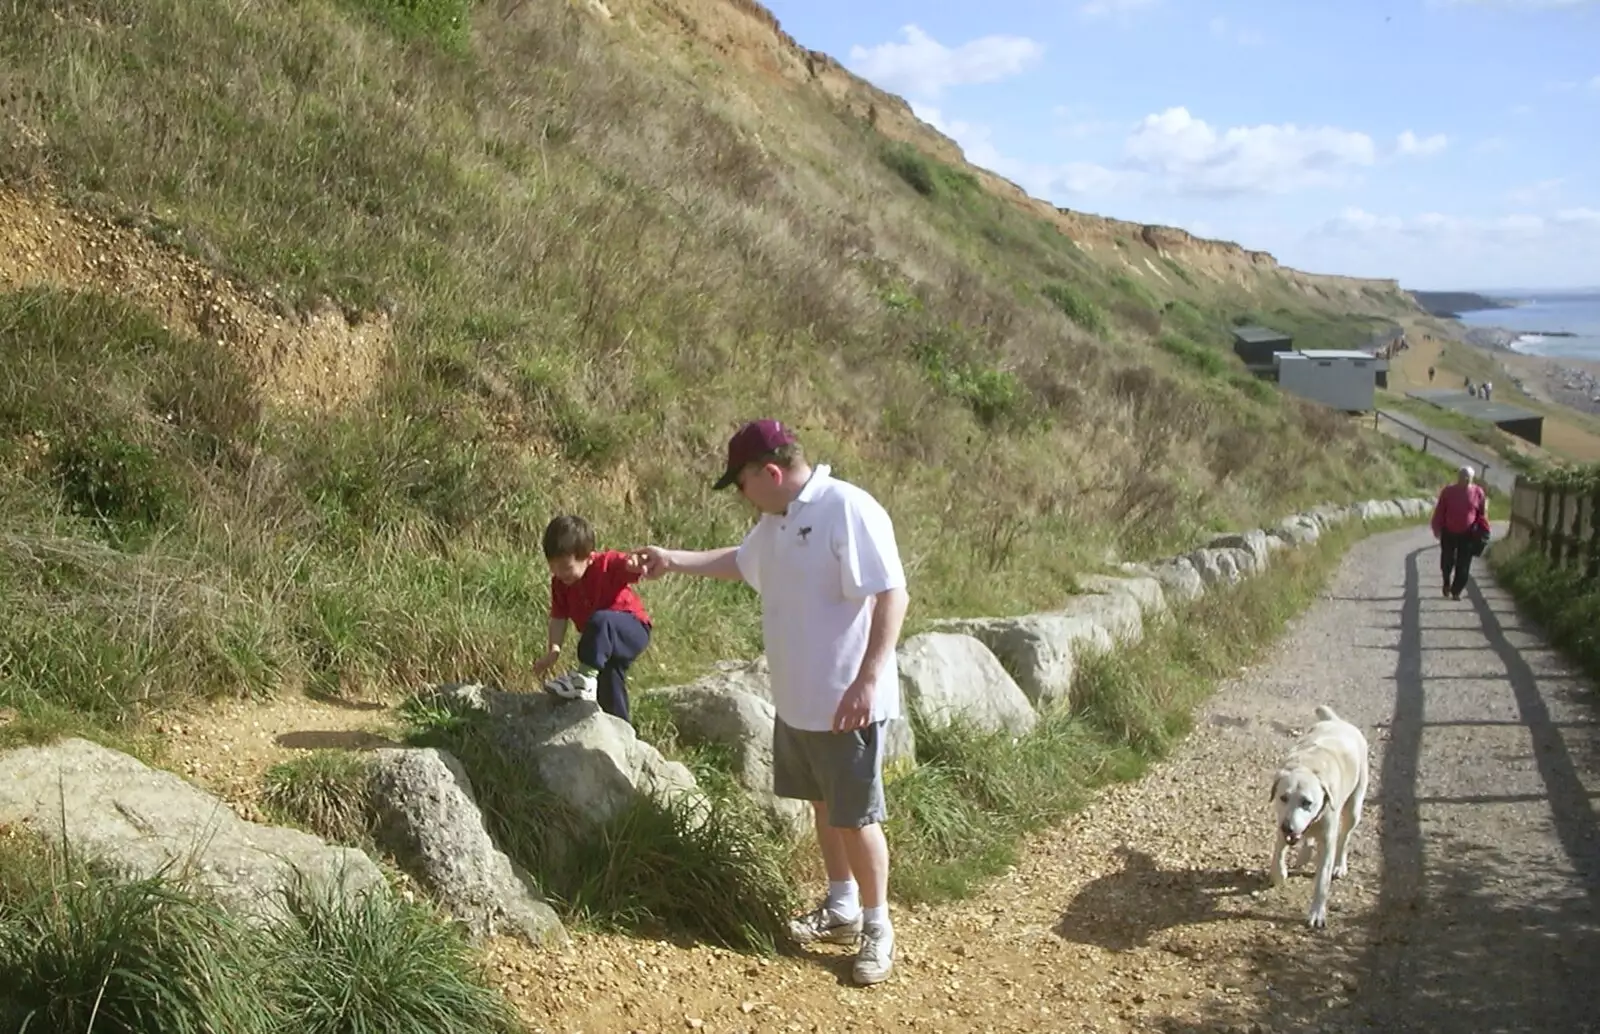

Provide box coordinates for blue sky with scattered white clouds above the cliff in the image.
[768,0,1600,288]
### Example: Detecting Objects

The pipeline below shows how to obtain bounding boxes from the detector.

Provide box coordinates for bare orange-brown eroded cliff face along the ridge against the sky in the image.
[574,0,1411,307]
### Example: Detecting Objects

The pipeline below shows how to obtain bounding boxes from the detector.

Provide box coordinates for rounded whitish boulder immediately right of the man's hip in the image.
[898,632,1038,736]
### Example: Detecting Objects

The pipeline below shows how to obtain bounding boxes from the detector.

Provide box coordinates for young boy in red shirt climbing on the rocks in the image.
[533,517,650,722]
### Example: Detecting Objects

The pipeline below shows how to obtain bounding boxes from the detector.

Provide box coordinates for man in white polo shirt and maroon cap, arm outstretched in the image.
[640,419,909,984]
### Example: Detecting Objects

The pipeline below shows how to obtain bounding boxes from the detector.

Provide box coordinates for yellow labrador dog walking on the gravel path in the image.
[1272,706,1366,928]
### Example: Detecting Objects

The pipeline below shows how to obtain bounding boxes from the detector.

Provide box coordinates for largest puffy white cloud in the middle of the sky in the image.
[1123,107,1378,195]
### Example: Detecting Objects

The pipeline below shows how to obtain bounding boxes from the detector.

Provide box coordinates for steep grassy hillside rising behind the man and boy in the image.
[0,0,1432,727]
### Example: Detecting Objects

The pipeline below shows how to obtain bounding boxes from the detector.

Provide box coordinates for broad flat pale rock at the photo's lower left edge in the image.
[0,739,387,919]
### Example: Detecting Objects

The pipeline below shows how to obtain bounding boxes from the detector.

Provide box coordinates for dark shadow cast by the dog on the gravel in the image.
[1054,848,1270,951]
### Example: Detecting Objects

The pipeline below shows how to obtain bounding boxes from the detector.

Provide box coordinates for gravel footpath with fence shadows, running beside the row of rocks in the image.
[499,531,1600,1034]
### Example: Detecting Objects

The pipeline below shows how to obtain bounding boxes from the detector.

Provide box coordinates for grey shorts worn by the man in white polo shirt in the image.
[773,719,886,829]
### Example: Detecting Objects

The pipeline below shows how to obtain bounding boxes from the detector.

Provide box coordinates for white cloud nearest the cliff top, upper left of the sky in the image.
[850,26,1045,99]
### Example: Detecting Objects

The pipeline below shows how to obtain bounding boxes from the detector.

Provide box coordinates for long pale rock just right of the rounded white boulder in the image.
[933,613,1112,709]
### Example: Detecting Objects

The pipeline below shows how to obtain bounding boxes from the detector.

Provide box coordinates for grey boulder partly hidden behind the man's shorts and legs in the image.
[654,677,812,836]
